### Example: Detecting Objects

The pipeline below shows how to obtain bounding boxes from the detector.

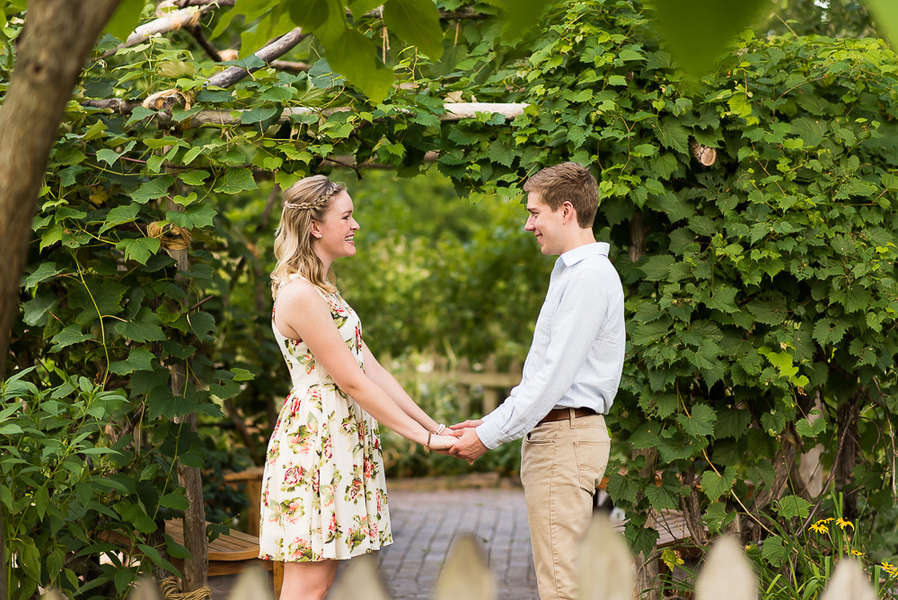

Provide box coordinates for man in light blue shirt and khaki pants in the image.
[450,163,625,600]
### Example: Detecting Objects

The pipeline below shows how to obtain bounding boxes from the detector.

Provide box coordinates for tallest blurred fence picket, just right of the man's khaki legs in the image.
[579,513,635,600]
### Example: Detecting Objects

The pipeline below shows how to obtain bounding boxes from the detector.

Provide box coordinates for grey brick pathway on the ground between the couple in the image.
[378,482,539,600]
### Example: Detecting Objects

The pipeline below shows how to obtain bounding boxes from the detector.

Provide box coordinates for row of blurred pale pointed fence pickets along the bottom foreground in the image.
[45,513,877,600]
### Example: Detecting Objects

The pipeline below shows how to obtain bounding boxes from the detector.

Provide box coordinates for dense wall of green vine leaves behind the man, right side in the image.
[440,1,898,564]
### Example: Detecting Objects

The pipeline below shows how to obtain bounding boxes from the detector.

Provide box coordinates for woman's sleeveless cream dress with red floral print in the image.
[259,275,393,562]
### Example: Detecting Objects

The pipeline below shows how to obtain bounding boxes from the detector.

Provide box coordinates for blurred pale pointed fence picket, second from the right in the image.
[695,536,758,600]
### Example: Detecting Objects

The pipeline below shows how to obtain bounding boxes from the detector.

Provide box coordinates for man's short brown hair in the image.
[524,162,599,229]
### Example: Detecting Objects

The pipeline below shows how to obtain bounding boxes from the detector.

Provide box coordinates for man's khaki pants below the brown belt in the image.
[521,415,611,600]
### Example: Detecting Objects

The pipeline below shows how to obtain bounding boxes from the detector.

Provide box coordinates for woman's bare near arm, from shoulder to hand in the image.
[275,281,455,450]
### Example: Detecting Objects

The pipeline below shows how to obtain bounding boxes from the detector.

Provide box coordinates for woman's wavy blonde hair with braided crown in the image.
[271,175,346,297]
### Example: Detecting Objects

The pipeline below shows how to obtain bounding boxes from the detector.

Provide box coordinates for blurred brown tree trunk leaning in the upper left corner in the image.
[0,0,119,598]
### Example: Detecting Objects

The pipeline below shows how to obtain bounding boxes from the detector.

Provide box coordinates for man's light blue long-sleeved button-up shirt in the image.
[476,242,626,449]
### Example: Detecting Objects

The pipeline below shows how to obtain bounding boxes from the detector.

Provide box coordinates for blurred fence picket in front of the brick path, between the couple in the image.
[433,535,496,600]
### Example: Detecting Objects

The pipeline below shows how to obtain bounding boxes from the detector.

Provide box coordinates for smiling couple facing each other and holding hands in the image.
[259,163,625,600]
